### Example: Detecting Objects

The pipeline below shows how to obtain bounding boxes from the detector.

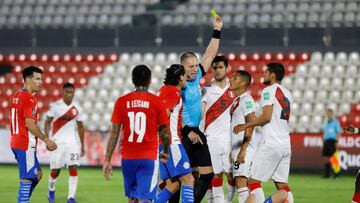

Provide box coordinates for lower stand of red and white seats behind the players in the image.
[0,52,360,133]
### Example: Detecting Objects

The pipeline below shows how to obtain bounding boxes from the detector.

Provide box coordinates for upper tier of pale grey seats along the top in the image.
[0,0,360,28]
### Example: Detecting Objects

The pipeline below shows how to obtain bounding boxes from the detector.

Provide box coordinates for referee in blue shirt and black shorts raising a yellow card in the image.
[180,16,223,203]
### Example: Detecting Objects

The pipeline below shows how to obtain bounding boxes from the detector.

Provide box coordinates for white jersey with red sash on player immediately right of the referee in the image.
[201,81,235,142]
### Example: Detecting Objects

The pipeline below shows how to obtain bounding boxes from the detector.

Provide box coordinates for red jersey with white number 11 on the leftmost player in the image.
[10,89,39,150]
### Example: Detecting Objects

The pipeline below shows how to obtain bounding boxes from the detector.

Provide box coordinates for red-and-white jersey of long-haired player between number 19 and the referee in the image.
[159,85,183,144]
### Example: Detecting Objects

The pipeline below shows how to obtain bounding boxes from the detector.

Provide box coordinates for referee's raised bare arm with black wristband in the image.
[200,16,223,72]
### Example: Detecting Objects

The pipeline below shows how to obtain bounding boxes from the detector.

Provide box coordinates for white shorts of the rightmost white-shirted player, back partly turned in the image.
[251,142,291,183]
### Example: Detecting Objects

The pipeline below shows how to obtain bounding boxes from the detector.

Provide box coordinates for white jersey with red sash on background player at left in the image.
[47,99,84,144]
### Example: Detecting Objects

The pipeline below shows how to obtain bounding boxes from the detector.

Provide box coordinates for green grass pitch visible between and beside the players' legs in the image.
[0,165,355,203]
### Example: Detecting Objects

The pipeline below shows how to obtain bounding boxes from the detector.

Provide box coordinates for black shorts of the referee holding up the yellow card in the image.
[181,128,212,167]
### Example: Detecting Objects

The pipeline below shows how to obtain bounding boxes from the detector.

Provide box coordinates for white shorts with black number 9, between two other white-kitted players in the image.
[231,145,256,178]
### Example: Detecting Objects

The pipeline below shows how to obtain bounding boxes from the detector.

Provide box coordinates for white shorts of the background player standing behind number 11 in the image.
[50,143,80,169]
